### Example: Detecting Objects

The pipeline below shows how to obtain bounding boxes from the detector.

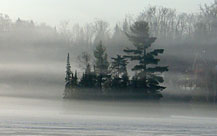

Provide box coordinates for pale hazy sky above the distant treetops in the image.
[0,0,214,26]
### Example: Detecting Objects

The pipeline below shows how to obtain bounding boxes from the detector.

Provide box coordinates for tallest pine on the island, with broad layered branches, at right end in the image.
[124,21,168,93]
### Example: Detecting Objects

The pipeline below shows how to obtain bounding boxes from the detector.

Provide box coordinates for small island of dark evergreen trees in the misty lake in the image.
[63,21,168,100]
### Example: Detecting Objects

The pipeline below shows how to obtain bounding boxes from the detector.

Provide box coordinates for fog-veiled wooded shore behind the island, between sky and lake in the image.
[0,2,217,103]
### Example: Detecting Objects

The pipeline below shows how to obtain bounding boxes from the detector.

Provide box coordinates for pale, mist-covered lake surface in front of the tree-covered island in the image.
[0,96,217,136]
